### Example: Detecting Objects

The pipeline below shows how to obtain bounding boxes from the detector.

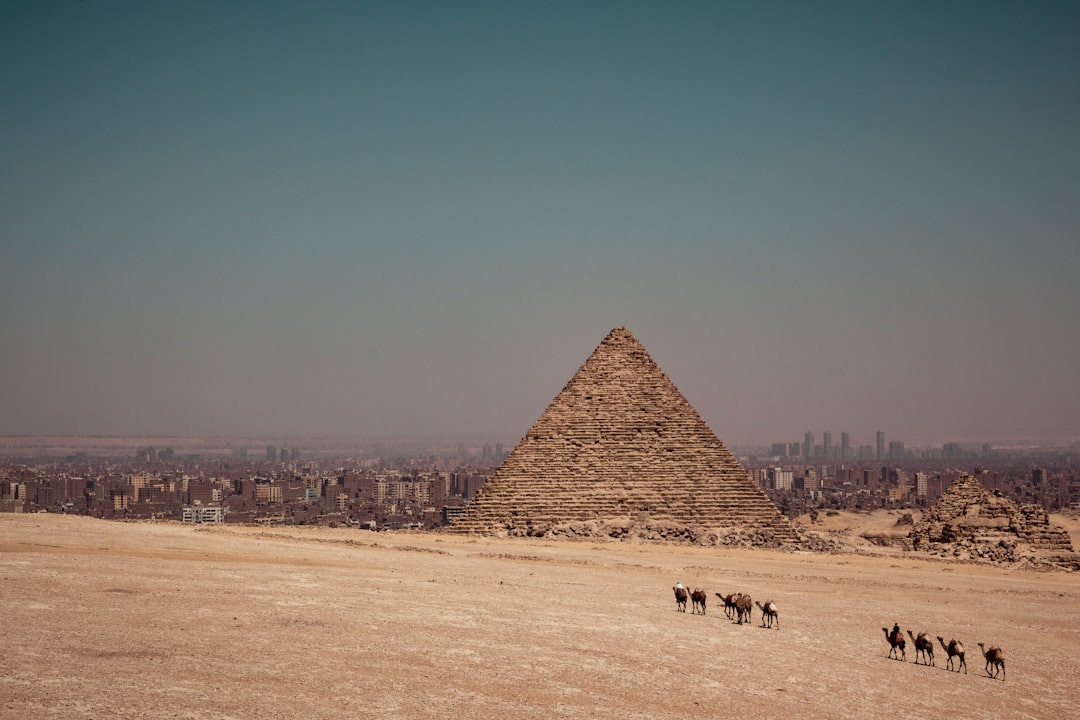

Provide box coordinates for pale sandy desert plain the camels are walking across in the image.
[0,514,1080,720]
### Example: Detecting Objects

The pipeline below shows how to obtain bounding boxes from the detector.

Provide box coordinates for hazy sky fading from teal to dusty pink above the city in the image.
[0,0,1080,445]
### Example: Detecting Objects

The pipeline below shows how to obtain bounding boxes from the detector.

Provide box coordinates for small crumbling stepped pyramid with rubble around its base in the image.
[909,475,1072,562]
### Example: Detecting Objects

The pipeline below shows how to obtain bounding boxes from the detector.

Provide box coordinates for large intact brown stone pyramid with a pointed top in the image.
[448,327,799,545]
